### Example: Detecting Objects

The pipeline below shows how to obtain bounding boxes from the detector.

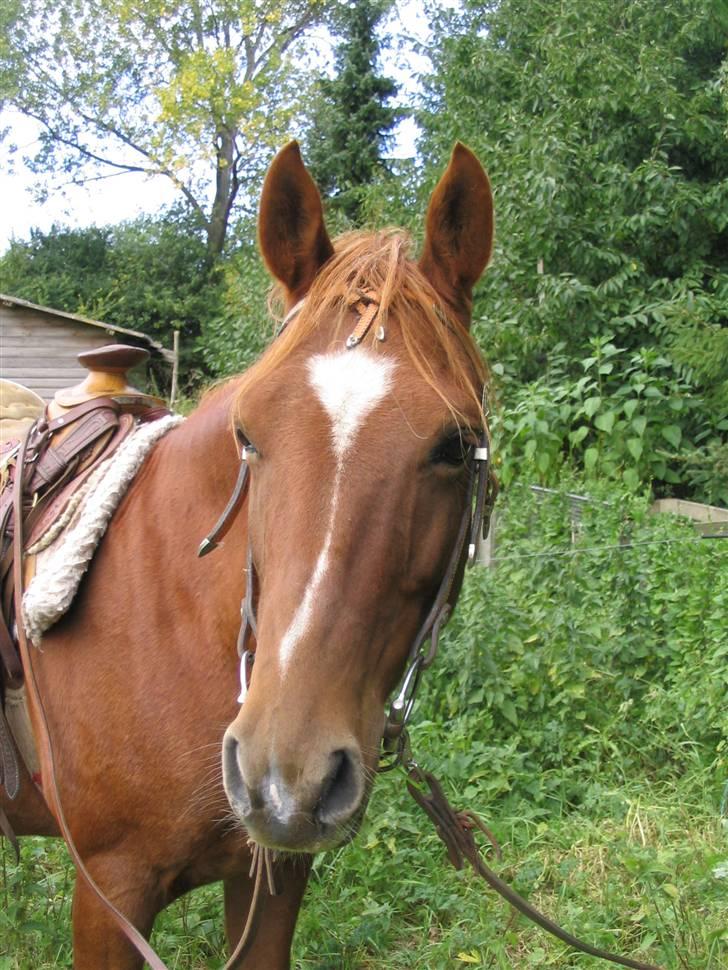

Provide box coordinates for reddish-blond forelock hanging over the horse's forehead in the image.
[233,229,488,424]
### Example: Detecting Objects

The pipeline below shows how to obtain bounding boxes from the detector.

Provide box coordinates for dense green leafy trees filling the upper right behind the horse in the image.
[420,0,728,500]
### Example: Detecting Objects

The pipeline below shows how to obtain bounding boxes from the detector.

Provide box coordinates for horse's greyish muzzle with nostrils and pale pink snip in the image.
[222,725,366,852]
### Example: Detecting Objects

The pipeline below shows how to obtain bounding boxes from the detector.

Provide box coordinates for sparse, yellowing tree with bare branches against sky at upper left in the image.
[0,0,330,262]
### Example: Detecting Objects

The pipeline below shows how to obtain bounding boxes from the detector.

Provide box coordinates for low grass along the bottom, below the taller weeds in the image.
[0,771,728,970]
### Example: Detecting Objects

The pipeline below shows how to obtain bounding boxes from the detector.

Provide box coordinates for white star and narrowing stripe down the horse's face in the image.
[280,348,394,673]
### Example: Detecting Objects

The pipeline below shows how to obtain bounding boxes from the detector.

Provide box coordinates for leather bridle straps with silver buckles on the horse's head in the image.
[197,292,498,771]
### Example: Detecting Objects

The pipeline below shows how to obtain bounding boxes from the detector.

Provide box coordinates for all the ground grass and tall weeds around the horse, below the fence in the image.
[0,483,728,970]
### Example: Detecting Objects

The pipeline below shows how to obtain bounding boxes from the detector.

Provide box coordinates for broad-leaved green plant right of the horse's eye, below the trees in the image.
[493,335,697,491]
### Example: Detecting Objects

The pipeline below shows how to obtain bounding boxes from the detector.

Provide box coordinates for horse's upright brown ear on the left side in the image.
[258,141,334,301]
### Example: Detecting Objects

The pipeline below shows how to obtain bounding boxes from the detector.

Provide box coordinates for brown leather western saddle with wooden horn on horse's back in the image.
[0,344,169,804]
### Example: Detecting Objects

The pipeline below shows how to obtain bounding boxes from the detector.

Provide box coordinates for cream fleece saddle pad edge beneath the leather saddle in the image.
[23,415,184,645]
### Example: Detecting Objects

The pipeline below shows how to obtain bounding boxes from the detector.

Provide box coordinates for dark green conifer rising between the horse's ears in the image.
[307,0,398,225]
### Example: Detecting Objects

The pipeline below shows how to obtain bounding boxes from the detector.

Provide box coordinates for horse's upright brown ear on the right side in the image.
[419,142,493,326]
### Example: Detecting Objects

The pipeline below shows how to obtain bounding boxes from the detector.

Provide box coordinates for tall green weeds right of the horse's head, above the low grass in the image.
[423,472,728,811]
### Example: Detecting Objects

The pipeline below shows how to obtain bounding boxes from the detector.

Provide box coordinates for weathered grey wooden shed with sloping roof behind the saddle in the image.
[0,293,173,401]
